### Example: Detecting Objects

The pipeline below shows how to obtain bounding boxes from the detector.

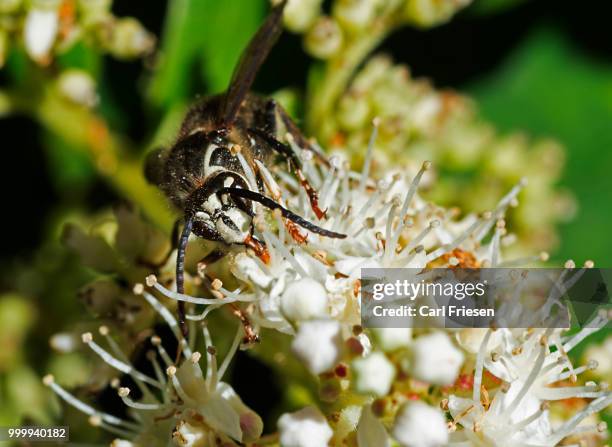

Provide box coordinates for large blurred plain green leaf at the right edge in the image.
[468,28,612,265]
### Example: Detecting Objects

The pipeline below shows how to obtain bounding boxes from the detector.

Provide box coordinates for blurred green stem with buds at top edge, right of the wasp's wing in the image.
[282,0,471,141]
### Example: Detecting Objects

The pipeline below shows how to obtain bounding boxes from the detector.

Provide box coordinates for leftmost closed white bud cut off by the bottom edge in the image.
[278,407,333,447]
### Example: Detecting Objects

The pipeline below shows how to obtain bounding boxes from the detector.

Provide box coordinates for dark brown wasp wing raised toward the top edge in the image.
[218,0,287,128]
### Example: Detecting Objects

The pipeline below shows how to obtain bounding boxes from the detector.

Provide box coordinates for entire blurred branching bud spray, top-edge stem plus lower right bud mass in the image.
[278,0,575,252]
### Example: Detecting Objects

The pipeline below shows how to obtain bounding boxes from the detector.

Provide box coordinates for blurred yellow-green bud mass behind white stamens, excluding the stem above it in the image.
[321,56,575,254]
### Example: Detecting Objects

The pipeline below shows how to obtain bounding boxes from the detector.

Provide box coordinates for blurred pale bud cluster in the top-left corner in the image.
[0,0,155,66]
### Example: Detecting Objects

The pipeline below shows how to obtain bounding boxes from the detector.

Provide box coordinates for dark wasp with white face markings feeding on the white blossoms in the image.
[145,0,346,342]
